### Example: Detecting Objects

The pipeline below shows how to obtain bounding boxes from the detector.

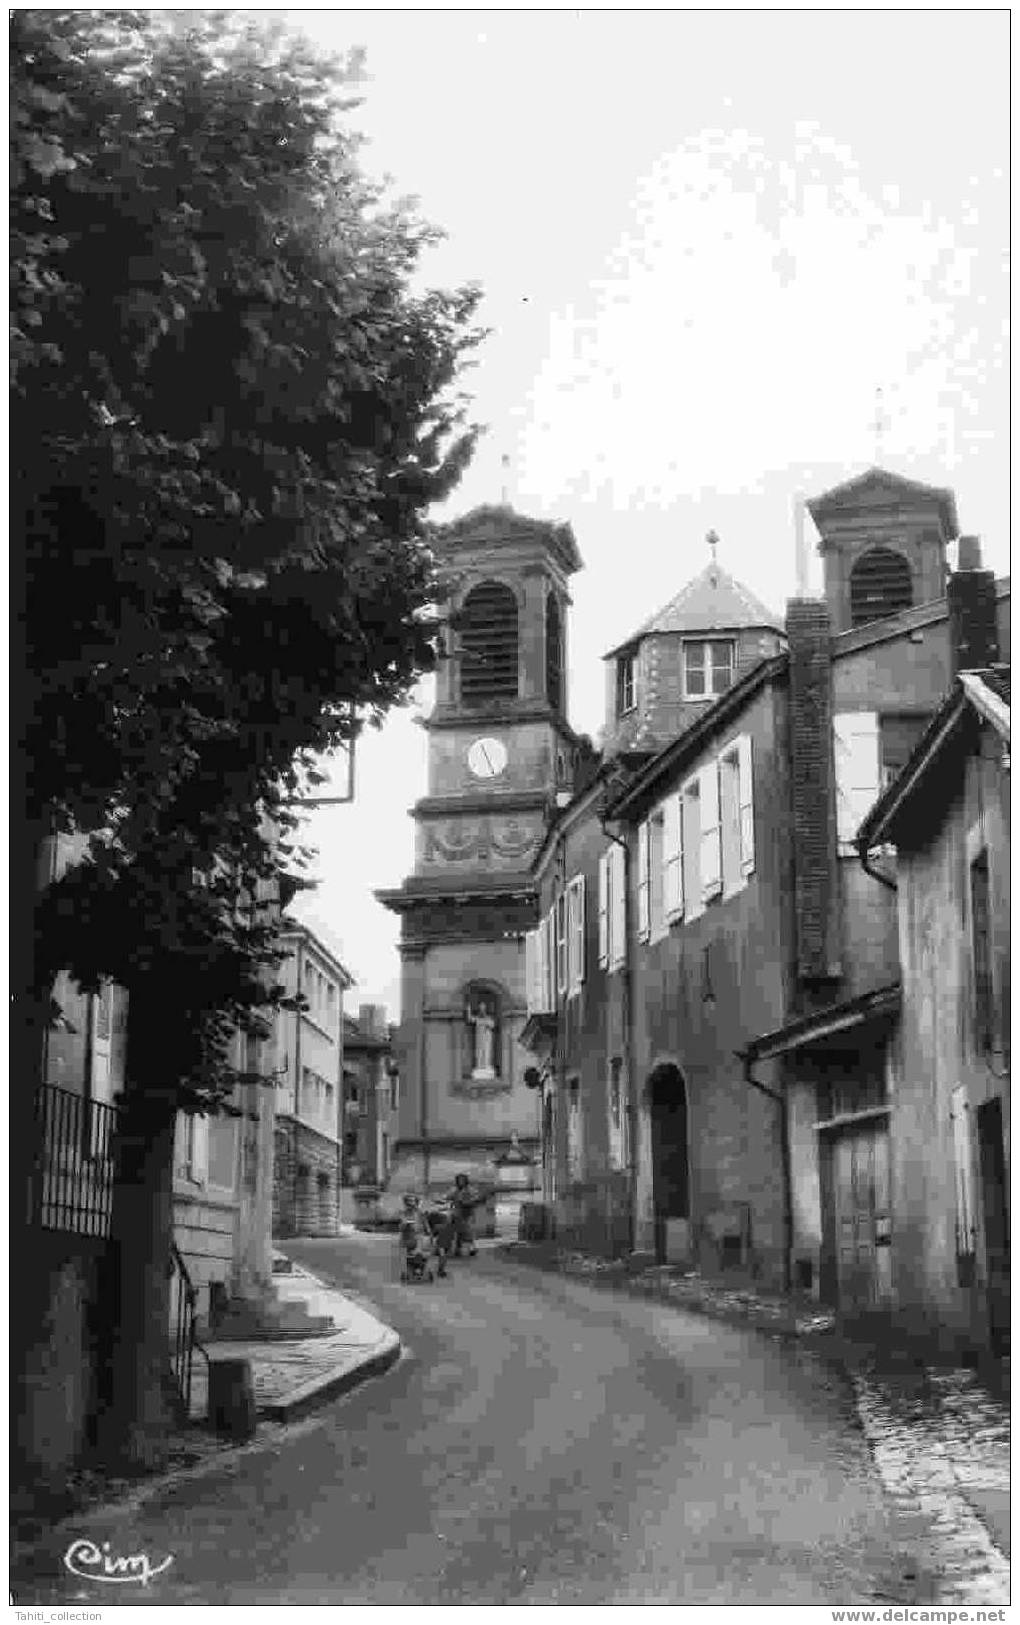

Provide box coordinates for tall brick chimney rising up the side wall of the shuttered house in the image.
[786,598,841,982]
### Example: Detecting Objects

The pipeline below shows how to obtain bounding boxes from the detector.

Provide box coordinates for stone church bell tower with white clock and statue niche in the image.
[378,507,581,1190]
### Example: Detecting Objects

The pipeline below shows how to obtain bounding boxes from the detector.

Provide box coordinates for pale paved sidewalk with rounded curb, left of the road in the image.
[192,1253,401,1422]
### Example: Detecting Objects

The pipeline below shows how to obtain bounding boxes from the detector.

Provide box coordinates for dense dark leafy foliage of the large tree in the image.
[11,11,481,1099]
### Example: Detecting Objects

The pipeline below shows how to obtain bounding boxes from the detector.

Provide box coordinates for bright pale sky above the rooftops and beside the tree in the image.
[286,10,1009,1019]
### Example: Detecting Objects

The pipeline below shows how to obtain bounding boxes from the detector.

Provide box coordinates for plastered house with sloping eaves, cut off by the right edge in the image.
[858,659,1010,1354]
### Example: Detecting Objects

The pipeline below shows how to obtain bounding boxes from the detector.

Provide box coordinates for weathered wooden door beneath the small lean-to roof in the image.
[833,1121,892,1310]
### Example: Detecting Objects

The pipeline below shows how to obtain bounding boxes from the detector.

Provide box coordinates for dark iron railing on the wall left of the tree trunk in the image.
[32,1084,119,1237]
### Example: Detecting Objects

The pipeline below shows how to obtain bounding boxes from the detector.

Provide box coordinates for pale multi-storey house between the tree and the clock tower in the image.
[273,925,352,1238]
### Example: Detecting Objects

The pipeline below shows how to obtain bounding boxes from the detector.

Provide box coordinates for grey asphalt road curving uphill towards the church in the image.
[18,1237,942,1606]
